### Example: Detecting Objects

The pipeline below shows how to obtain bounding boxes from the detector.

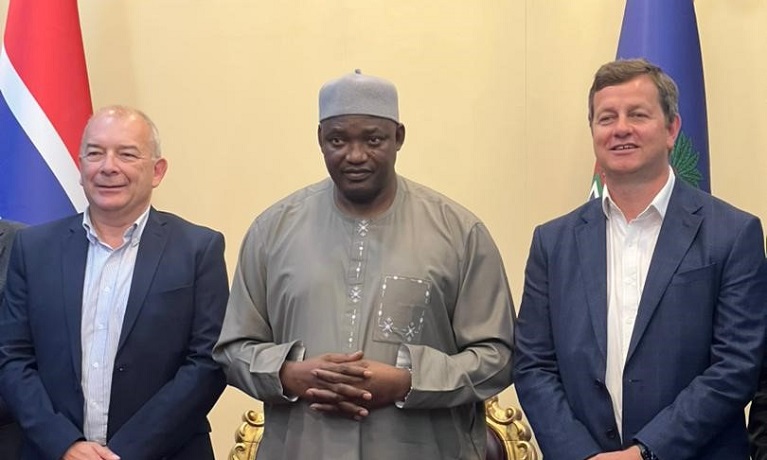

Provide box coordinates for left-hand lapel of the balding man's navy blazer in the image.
[61,214,88,381]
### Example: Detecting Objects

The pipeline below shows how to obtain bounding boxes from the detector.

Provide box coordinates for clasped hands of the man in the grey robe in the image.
[280,351,411,420]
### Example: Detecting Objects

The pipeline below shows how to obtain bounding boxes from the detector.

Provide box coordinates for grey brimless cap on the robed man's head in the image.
[320,69,399,123]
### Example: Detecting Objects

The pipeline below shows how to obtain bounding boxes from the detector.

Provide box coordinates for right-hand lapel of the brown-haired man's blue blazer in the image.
[626,178,703,362]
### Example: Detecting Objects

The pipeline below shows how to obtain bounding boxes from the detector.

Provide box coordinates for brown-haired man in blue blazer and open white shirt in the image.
[515,60,766,460]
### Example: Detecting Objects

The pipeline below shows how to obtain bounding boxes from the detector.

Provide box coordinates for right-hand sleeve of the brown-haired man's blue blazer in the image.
[636,217,767,458]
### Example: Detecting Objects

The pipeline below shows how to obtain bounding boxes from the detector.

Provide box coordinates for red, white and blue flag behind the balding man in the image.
[0,0,92,224]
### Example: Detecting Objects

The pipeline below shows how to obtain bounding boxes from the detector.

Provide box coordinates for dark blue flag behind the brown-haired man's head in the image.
[590,0,711,198]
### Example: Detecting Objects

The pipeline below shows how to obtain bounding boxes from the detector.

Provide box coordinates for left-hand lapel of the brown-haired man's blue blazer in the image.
[575,200,607,362]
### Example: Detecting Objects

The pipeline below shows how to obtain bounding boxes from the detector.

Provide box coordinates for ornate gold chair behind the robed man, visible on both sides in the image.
[228,396,539,460]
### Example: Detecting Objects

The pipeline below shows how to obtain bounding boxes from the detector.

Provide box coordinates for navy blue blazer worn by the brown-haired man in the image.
[515,179,767,460]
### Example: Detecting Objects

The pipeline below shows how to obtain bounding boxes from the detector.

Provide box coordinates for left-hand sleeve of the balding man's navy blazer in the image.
[0,232,84,458]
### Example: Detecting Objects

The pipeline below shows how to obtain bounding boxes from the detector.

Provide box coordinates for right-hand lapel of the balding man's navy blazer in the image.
[117,208,168,353]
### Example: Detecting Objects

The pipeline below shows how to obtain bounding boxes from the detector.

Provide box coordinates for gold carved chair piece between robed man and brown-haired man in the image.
[485,396,538,460]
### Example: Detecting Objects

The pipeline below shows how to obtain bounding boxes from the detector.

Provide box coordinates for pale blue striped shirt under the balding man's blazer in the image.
[80,208,149,445]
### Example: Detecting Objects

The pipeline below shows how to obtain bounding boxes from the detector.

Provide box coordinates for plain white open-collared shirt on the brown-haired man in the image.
[602,167,676,436]
